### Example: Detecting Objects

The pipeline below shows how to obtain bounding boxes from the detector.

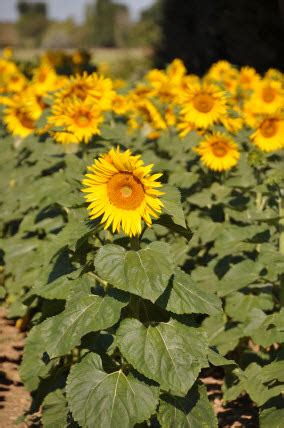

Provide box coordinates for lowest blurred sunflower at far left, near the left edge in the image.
[3,93,38,138]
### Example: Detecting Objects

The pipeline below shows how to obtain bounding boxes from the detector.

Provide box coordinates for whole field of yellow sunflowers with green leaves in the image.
[0,50,284,428]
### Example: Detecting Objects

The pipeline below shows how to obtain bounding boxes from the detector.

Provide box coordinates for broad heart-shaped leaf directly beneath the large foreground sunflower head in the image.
[95,242,174,302]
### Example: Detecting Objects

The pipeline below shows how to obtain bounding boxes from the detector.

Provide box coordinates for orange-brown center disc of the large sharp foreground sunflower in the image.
[107,172,145,210]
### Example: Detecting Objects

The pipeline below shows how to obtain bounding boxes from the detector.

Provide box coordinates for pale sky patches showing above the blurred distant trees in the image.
[0,0,154,22]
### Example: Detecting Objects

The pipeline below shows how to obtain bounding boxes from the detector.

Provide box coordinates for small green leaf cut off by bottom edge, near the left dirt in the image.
[42,389,68,428]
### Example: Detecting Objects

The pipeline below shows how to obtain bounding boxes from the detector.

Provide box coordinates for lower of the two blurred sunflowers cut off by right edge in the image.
[250,114,284,152]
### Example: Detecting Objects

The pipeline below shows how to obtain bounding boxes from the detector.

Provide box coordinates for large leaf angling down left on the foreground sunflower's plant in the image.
[42,290,128,358]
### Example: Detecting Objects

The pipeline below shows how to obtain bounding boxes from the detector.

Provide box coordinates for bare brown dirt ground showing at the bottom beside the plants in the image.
[0,308,259,428]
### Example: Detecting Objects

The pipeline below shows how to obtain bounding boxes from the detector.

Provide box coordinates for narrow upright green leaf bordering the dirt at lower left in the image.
[20,324,53,391]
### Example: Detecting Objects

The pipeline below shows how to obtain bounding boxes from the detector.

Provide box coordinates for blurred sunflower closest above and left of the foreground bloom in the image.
[48,98,104,144]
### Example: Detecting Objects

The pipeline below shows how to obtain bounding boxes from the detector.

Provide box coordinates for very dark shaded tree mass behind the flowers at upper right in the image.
[156,0,284,73]
